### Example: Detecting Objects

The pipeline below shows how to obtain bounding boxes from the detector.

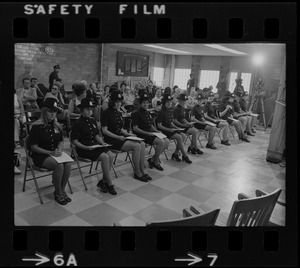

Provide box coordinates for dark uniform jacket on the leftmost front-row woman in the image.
[29,121,63,167]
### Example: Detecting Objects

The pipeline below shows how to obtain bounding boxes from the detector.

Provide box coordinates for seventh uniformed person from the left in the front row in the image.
[191,95,217,150]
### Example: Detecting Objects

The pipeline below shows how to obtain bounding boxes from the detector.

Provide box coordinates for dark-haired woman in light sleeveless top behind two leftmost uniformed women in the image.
[69,84,86,122]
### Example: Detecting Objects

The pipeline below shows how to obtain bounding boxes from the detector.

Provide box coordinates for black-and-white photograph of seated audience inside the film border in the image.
[13,42,287,228]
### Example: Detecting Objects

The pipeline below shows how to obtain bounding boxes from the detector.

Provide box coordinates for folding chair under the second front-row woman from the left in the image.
[69,131,117,191]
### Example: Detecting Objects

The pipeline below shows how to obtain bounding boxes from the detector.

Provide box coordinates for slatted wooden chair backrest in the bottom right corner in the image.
[227,189,281,227]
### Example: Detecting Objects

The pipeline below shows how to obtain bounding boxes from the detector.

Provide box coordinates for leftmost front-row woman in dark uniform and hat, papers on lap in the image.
[29,98,72,205]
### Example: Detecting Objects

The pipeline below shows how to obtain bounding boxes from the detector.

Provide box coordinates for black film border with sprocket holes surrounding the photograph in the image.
[0,2,297,266]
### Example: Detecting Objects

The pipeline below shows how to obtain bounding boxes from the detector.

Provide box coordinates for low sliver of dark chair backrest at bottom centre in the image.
[146,208,220,226]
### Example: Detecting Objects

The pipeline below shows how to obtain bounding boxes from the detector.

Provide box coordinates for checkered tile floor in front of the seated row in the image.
[14,126,285,226]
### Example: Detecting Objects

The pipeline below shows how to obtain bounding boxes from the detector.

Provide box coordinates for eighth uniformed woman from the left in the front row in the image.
[203,95,230,146]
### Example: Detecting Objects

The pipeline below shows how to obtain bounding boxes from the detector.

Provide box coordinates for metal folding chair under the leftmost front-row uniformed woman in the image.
[22,135,73,204]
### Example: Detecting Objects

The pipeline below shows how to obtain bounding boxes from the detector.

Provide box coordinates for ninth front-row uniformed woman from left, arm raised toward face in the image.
[219,91,250,142]
